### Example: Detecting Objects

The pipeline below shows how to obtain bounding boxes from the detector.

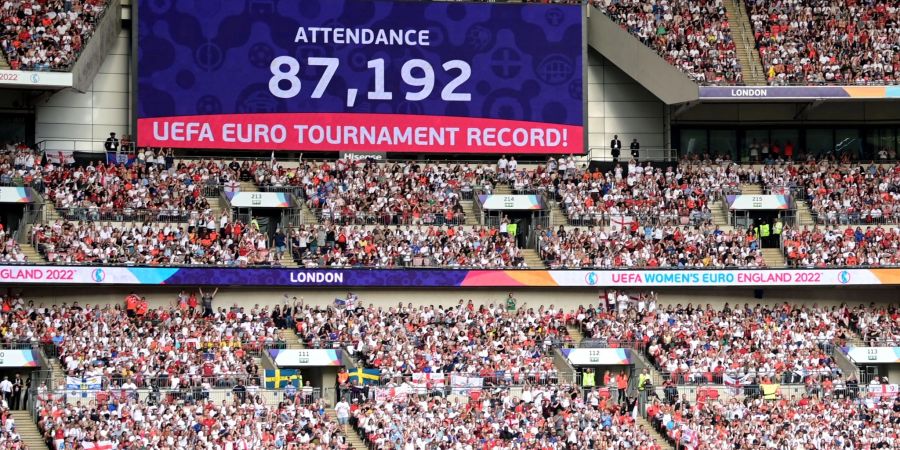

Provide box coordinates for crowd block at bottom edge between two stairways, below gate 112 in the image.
[352,386,661,450]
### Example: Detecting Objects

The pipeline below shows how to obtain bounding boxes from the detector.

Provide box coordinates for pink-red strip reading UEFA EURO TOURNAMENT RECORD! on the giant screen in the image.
[138,113,584,153]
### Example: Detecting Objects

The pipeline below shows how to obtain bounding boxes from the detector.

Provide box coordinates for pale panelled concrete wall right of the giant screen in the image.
[588,48,669,156]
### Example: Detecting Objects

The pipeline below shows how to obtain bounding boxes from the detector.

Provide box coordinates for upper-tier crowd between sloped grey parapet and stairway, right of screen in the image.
[592,0,743,84]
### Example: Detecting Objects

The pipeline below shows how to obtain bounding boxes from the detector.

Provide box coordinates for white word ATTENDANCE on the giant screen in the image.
[294,27,429,47]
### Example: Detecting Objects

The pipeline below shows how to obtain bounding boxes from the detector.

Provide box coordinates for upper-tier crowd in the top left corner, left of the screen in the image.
[0,0,107,71]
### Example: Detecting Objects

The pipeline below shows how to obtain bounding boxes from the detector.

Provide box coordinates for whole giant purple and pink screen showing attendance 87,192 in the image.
[137,0,585,153]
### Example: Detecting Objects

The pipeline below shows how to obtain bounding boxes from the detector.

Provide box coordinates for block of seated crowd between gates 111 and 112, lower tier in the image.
[295,300,569,384]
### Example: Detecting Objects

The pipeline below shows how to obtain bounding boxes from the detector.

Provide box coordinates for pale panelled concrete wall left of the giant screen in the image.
[35,29,131,151]
